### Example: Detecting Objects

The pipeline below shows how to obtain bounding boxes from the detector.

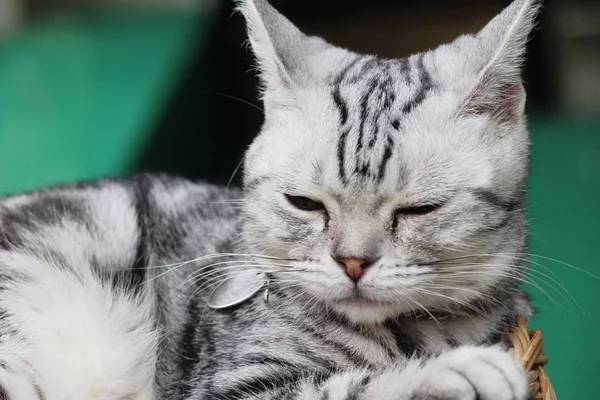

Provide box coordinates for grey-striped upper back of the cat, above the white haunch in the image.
[0,175,241,269]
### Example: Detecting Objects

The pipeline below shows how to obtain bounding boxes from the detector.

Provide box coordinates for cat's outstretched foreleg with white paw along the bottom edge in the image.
[209,347,527,400]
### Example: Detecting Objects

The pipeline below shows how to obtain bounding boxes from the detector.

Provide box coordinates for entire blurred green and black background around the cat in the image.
[0,0,600,399]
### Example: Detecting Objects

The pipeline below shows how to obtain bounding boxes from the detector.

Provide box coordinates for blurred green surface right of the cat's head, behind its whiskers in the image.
[525,117,600,400]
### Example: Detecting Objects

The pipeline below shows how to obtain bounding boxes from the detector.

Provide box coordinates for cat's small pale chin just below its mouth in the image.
[330,298,404,324]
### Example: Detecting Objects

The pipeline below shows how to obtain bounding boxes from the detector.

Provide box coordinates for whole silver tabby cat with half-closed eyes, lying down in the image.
[0,0,537,400]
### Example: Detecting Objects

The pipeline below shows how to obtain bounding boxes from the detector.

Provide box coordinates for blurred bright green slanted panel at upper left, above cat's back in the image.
[0,8,206,194]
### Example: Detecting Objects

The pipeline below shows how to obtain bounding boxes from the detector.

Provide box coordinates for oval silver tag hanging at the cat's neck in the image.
[207,271,268,310]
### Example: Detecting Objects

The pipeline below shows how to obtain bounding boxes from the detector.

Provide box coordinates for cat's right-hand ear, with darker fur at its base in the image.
[461,0,540,122]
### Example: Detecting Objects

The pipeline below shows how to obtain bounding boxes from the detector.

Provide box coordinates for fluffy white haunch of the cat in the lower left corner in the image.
[0,251,158,400]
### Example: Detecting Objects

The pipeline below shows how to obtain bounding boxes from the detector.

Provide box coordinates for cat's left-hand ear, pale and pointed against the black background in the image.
[236,0,327,98]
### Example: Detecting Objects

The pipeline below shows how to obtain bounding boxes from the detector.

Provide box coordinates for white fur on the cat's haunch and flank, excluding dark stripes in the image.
[0,185,158,400]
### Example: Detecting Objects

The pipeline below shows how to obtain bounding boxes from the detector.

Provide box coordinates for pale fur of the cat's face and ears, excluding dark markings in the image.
[242,0,537,323]
